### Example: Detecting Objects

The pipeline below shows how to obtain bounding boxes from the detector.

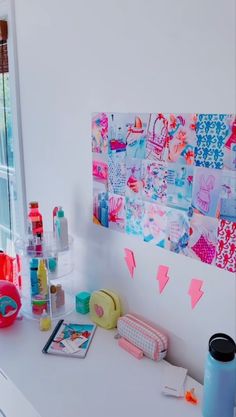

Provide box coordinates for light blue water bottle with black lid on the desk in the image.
[202,333,236,417]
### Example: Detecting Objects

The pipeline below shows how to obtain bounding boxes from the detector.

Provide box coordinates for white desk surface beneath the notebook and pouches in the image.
[0,313,202,417]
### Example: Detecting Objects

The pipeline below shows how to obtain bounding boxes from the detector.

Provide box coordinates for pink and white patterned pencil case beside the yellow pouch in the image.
[117,314,168,361]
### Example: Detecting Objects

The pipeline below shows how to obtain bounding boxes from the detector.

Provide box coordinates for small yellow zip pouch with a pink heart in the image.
[89,289,121,329]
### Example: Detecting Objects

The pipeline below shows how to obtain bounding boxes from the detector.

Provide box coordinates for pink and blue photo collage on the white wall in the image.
[92,112,236,273]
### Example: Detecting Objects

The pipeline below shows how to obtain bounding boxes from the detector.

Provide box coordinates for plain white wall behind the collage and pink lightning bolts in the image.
[12,0,235,380]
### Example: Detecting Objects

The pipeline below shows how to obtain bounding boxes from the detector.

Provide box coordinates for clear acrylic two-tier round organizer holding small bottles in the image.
[15,232,74,319]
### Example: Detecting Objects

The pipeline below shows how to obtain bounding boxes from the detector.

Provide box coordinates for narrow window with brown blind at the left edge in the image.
[0,6,25,254]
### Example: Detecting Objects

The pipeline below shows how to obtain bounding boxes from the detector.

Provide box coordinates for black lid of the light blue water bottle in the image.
[209,333,236,362]
